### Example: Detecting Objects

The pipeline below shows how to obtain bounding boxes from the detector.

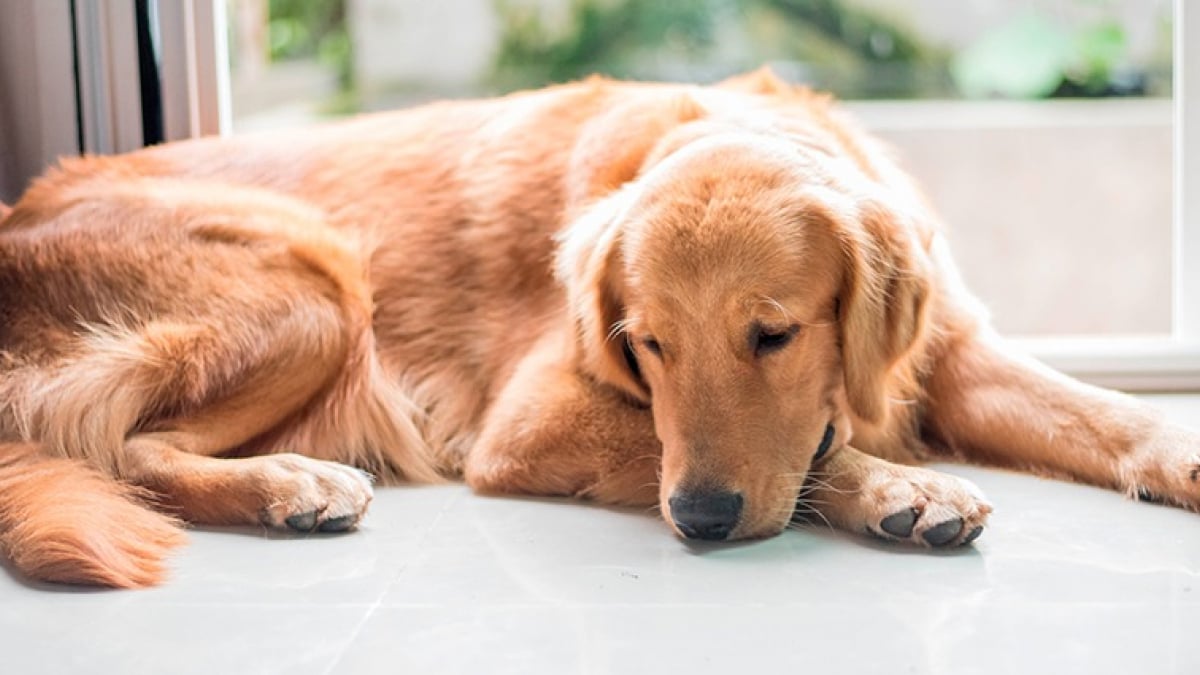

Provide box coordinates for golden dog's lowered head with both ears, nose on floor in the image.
[558,111,929,539]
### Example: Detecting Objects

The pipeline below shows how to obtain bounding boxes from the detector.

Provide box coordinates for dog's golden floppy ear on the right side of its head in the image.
[839,203,929,423]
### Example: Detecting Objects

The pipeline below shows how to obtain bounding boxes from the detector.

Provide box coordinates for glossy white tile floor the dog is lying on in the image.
[0,396,1200,675]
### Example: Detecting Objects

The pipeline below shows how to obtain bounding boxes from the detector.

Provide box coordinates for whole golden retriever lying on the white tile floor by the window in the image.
[0,71,1200,587]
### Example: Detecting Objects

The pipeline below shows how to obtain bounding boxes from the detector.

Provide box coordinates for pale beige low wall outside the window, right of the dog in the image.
[853,100,1172,335]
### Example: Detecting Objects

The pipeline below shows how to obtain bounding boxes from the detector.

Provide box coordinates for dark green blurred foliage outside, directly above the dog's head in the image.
[492,0,949,97]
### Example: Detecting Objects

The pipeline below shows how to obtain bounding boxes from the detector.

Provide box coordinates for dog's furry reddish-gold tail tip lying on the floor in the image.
[0,443,185,589]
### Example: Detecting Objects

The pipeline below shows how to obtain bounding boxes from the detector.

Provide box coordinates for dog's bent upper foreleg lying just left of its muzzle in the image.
[464,333,662,506]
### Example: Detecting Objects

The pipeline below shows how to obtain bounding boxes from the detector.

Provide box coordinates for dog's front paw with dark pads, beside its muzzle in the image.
[863,467,992,548]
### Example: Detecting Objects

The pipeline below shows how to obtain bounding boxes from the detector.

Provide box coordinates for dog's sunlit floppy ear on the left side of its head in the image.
[556,190,650,404]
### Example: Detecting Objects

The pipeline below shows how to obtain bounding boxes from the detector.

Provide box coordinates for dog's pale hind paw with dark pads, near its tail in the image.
[253,454,373,532]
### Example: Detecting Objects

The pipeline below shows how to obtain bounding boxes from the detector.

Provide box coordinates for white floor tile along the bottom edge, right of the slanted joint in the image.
[332,598,1200,675]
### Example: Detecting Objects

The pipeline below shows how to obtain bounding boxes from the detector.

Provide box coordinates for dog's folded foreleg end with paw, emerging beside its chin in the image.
[796,446,991,546]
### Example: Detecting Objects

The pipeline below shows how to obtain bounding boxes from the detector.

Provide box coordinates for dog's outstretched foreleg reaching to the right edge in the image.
[924,329,1200,509]
